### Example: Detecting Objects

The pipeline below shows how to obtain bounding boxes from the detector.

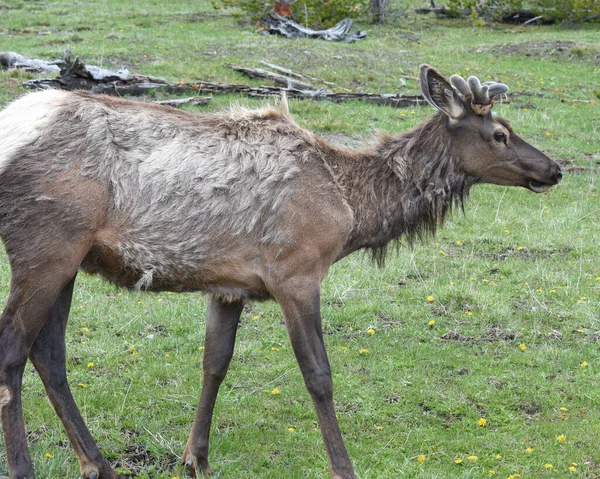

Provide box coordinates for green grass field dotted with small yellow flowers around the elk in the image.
[0,0,600,479]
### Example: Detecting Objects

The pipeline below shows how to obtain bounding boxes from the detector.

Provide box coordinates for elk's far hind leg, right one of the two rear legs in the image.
[29,278,118,479]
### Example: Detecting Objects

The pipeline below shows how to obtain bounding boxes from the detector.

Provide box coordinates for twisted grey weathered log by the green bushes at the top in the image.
[261,11,367,42]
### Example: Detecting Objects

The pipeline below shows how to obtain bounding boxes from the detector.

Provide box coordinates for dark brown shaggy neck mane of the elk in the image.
[326,113,474,265]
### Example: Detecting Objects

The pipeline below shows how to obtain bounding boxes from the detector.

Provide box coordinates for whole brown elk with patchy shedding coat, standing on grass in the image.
[0,65,561,479]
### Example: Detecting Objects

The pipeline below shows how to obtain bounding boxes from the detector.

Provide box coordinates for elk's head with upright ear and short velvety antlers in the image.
[421,65,562,193]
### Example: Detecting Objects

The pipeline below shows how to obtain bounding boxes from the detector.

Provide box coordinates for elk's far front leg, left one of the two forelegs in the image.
[183,296,244,477]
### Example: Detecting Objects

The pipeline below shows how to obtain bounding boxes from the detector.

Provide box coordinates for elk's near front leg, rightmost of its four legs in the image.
[276,284,356,479]
